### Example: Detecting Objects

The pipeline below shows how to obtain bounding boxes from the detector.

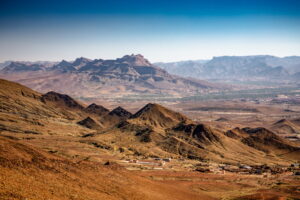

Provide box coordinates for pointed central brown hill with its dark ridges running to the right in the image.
[91,104,300,165]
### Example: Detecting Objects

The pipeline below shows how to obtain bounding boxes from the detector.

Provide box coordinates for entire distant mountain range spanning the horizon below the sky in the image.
[0,54,300,98]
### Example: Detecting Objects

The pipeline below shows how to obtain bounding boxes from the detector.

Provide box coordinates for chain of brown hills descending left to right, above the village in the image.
[0,80,300,165]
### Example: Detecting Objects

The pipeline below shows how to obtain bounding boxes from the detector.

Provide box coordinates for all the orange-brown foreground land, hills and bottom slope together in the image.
[0,79,300,200]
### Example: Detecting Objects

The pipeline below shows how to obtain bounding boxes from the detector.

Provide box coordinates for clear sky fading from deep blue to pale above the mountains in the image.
[0,0,300,62]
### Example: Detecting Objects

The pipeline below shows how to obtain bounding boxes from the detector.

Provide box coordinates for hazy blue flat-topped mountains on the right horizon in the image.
[155,55,300,81]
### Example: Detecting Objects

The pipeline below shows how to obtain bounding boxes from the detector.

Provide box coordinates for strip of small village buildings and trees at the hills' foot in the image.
[117,158,300,177]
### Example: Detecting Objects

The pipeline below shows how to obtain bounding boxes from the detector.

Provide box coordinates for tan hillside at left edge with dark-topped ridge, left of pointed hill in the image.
[0,79,131,136]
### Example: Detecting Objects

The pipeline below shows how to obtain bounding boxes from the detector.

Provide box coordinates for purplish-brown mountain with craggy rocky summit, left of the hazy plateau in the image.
[0,55,221,98]
